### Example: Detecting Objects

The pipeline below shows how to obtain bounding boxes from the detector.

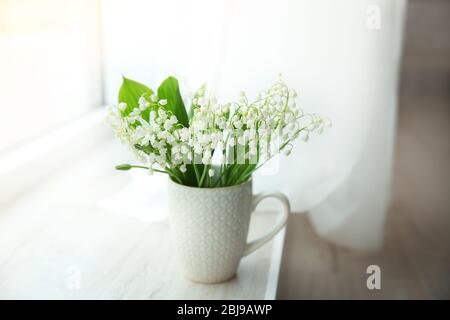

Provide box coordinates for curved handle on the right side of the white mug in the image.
[243,192,291,257]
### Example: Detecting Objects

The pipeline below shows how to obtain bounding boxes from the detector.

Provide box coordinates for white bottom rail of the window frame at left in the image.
[0,108,111,206]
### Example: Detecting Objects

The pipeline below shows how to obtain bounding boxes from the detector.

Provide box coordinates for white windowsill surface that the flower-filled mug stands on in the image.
[0,110,284,299]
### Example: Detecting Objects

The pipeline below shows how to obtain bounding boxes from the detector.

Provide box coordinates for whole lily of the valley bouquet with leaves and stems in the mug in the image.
[108,77,330,188]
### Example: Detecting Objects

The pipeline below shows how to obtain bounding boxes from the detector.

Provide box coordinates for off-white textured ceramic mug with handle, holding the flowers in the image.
[169,179,290,283]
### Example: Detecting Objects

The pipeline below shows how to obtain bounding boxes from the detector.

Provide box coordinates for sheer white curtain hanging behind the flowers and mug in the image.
[102,0,406,249]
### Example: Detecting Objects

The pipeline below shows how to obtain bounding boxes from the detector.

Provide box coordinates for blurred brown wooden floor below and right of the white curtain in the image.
[277,95,450,299]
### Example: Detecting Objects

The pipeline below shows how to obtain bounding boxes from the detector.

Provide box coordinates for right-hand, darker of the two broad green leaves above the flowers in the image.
[158,76,189,127]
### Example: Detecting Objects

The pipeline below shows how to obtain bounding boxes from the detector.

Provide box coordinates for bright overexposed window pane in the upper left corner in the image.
[0,0,102,153]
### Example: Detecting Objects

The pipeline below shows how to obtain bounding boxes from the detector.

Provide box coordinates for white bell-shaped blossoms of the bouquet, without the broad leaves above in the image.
[108,78,329,177]
